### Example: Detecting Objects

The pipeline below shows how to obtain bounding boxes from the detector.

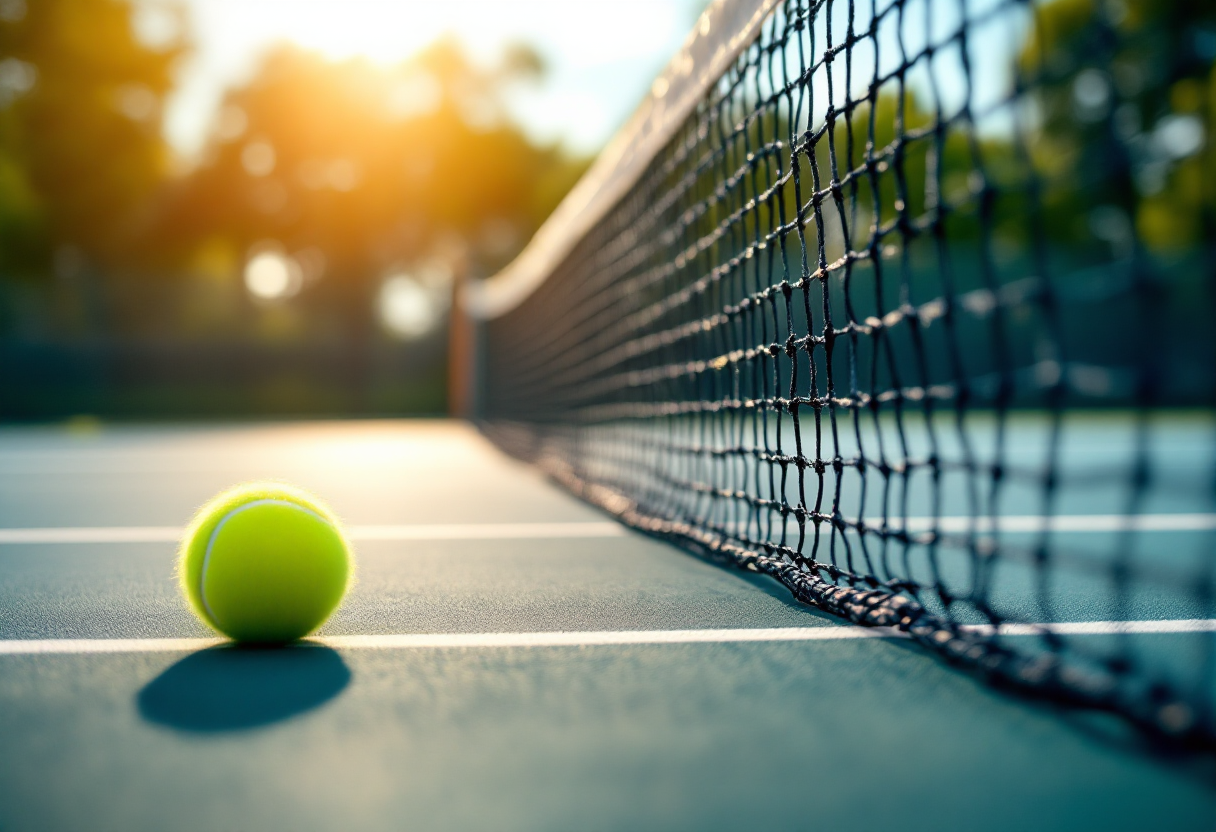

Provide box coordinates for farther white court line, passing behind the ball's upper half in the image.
[0,513,1216,544]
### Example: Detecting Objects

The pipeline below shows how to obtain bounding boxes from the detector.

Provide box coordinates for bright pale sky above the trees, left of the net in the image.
[155,0,705,158]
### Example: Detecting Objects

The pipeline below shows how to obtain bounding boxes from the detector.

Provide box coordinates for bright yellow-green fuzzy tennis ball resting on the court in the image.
[178,483,353,643]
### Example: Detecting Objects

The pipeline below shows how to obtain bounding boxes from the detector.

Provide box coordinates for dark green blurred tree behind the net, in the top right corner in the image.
[1019,0,1216,249]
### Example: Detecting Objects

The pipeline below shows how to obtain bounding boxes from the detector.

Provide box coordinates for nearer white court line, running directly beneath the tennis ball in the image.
[0,618,1216,656]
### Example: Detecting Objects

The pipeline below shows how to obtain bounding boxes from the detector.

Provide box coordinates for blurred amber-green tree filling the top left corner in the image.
[0,0,185,282]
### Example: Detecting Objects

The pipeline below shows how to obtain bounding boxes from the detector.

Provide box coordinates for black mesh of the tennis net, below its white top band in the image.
[479,0,1216,743]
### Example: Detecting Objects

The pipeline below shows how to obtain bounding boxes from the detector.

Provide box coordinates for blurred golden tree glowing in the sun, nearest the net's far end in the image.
[165,40,585,345]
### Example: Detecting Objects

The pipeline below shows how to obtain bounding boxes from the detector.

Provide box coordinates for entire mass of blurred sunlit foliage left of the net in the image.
[0,0,586,350]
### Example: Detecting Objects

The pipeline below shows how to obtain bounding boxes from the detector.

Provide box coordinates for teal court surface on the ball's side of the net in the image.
[0,421,1216,832]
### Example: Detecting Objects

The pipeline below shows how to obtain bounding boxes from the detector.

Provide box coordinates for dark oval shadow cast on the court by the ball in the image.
[136,643,350,733]
